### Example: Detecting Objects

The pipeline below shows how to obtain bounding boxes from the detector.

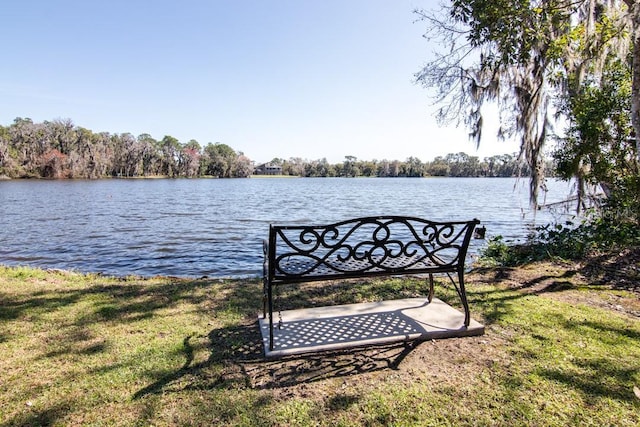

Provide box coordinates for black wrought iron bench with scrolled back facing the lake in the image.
[263,216,480,350]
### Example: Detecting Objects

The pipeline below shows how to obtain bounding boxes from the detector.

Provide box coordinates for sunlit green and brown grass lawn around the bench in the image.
[0,267,640,426]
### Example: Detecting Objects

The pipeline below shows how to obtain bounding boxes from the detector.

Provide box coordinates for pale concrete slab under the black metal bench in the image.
[259,298,484,358]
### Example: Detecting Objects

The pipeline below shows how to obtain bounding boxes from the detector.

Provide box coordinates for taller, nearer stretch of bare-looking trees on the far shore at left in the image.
[0,118,253,179]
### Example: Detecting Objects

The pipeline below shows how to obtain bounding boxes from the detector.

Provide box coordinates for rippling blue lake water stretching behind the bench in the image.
[0,178,571,277]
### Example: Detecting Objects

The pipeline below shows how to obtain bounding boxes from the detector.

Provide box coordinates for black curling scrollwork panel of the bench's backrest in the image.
[274,217,467,277]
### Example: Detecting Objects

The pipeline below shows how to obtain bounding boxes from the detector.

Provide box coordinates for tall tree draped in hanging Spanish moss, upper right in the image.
[416,0,640,202]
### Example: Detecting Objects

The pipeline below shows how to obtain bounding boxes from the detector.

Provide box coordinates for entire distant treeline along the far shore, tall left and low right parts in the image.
[0,118,552,179]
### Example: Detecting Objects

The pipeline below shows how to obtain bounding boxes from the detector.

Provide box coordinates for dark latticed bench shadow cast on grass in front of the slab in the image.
[133,322,420,399]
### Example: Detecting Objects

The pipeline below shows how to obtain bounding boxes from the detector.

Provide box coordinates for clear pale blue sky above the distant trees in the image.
[0,0,518,163]
